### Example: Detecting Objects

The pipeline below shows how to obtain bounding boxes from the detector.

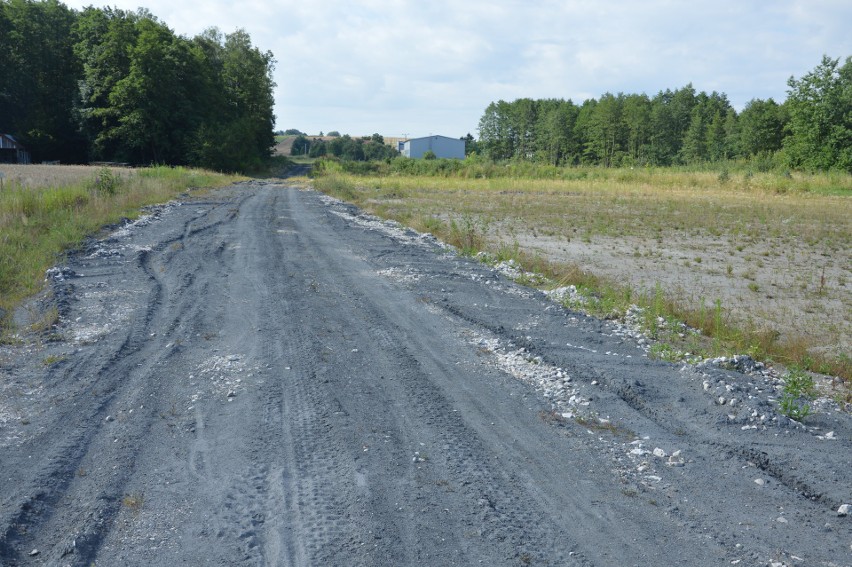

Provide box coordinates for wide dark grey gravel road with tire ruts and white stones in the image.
[0,180,852,567]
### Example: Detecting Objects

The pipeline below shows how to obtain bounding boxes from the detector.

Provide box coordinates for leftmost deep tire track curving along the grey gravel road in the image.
[0,194,253,565]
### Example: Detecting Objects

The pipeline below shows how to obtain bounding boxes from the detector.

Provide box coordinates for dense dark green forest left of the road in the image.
[0,0,275,171]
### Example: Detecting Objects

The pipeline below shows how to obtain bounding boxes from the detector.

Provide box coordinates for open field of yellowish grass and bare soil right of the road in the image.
[318,169,852,380]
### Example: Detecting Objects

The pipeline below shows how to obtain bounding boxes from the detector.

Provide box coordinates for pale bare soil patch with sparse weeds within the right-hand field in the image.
[510,230,852,355]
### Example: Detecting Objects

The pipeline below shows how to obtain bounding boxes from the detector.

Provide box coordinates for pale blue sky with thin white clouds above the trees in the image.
[63,0,852,138]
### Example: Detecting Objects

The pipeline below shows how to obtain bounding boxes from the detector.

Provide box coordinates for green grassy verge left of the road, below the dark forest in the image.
[0,166,238,328]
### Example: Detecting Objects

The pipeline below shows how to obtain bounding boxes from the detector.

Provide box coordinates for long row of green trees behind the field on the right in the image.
[476,56,852,171]
